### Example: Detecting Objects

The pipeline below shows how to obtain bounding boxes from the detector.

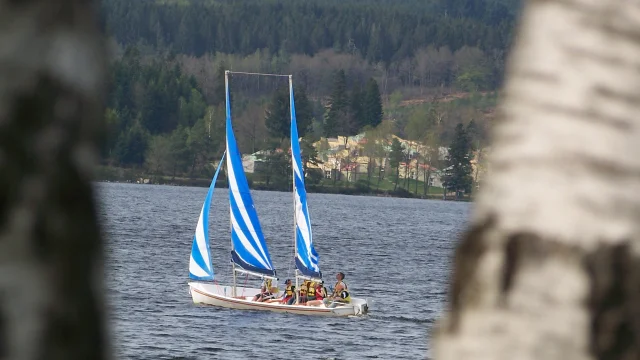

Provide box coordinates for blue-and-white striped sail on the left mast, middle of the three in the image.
[226,78,276,276]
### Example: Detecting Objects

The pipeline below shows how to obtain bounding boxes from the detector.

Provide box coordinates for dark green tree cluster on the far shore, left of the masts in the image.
[102,47,212,173]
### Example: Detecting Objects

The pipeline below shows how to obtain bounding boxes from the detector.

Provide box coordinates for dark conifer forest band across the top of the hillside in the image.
[102,0,516,60]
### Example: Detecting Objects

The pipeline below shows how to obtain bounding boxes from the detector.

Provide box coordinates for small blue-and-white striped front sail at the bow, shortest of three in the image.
[189,154,225,280]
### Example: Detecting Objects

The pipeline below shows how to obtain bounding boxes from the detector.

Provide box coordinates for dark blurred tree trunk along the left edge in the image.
[0,0,109,360]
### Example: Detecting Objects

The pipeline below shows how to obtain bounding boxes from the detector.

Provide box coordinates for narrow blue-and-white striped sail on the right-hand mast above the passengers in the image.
[289,82,322,278]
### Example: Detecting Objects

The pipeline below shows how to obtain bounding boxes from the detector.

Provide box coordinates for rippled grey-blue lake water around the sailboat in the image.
[97,183,470,359]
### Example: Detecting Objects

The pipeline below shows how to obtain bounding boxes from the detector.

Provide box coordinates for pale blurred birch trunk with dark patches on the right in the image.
[434,0,640,360]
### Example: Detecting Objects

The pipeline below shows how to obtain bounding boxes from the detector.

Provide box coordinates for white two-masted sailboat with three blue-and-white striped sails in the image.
[188,71,368,316]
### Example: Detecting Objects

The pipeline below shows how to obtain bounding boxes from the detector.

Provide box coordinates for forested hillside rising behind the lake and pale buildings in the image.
[102,0,519,187]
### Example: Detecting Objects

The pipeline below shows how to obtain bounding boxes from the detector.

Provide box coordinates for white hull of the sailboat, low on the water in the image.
[189,282,369,316]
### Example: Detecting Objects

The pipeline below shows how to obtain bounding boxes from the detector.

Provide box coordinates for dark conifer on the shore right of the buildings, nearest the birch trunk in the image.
[443,124,473,198]
